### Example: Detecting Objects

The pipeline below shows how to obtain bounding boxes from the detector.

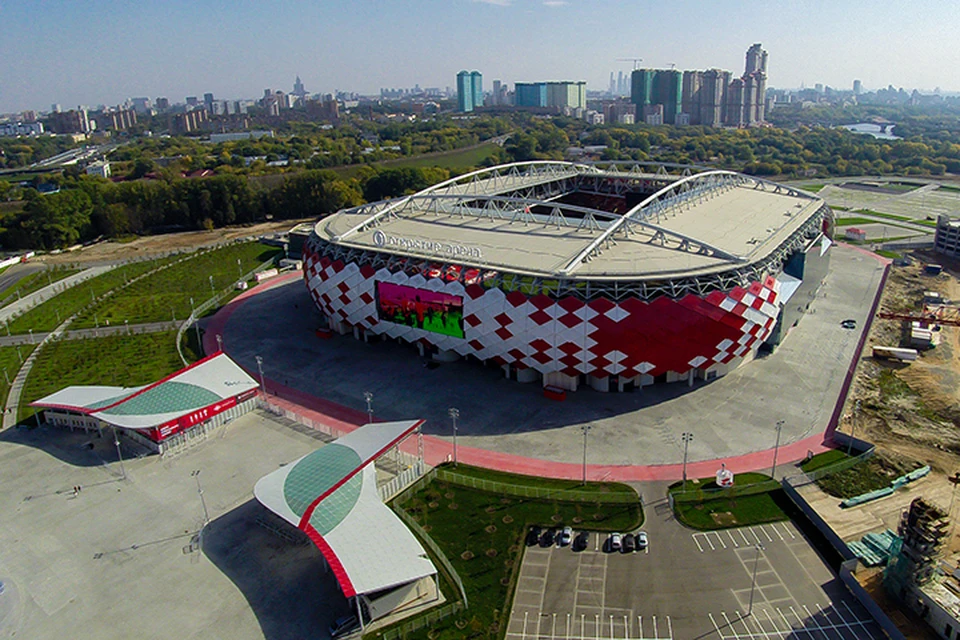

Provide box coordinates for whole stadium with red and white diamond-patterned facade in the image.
[303,161,833,391]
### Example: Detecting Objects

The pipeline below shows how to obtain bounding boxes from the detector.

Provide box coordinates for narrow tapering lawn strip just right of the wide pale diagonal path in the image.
[9,258,172,333]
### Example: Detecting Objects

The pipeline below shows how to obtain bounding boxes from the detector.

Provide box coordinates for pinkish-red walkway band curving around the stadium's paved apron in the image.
[203,254,889,481]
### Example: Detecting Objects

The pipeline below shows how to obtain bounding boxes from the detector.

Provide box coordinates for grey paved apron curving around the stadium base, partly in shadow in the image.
[216,246,884,466]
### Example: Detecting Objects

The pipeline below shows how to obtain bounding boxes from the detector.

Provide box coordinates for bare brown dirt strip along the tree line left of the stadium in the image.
[34,218,312,266]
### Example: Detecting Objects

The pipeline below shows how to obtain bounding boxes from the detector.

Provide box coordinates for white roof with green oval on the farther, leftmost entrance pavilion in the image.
[30,352,258,429]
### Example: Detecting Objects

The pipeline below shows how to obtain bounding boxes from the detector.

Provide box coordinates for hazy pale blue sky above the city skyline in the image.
[0,0,960,113]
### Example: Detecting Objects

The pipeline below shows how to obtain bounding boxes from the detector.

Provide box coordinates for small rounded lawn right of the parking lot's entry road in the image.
[669,473,788,531]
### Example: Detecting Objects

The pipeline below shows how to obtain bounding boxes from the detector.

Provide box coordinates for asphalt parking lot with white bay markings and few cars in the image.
[506,505,883,640]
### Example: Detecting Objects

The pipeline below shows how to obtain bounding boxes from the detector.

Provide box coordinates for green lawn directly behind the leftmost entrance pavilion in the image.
[13,331,183,420]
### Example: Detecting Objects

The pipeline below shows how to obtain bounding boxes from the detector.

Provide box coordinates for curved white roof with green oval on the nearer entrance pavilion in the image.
[253,420,437,597]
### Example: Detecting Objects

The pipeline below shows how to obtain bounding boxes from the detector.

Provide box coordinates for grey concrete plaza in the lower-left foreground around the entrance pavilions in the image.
[0,412,349,640]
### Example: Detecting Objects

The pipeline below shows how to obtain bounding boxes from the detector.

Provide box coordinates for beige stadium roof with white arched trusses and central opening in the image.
[315,162,824,279]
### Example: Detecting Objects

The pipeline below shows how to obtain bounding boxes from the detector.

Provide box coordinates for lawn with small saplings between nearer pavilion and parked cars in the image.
[390,465,642,640]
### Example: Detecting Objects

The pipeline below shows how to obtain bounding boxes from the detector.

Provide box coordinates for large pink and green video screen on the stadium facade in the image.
[377,282,464,338]
